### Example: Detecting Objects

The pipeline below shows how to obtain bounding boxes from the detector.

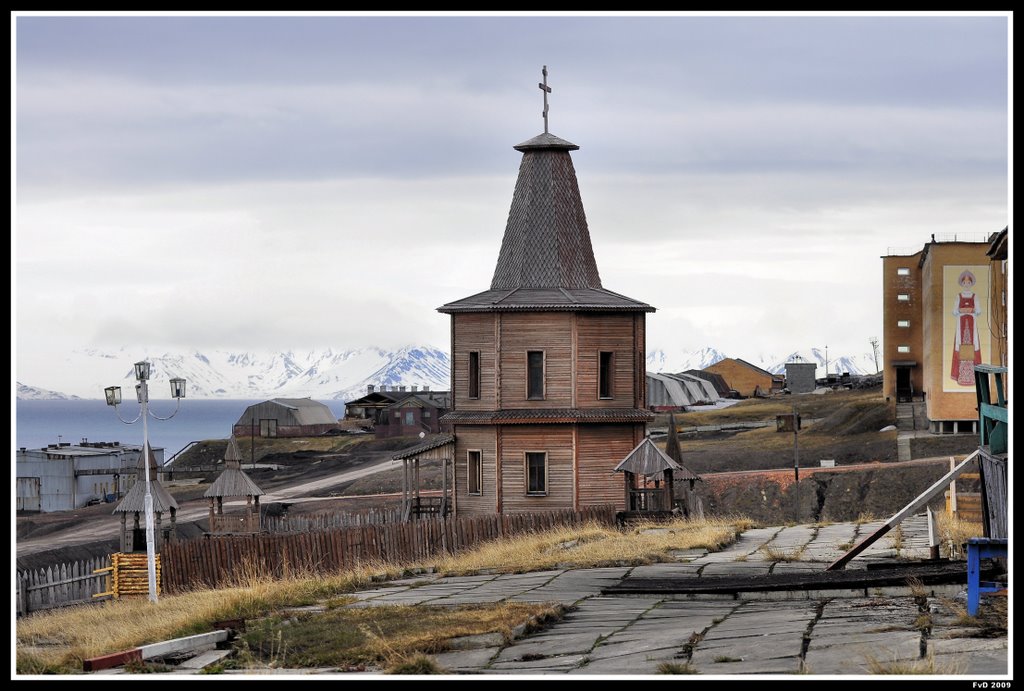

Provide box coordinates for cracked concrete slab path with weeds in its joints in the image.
[319,516,1009,676]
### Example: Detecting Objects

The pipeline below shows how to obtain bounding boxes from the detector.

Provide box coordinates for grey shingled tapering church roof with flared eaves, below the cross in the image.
[438,132,654,313]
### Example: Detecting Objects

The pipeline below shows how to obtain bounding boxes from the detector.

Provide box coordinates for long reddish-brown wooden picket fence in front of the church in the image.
[161,505,615,593]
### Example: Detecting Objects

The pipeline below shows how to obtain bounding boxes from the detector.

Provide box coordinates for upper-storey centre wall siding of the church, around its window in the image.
[497,312,573,409]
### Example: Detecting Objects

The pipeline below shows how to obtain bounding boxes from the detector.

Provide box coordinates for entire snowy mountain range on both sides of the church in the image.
[17,345,876,400]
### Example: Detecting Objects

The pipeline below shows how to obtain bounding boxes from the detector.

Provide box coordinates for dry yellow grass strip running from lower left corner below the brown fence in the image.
[16,564,401,674]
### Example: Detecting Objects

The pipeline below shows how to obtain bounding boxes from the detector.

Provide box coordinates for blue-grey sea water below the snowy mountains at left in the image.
[14,398,345,459]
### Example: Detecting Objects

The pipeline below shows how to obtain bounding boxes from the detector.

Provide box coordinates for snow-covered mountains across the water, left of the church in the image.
[18,346,451,400]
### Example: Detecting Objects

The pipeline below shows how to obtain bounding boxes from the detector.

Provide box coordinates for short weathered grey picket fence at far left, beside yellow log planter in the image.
[14,557,111,616]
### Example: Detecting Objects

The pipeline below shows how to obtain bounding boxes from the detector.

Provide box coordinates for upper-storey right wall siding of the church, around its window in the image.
[577,314,638,407]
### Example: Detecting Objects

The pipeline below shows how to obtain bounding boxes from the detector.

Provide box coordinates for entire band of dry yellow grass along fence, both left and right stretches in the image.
[16,519,750,674]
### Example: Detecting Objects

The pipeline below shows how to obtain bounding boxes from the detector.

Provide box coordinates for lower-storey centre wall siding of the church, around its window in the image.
[501,425,577,513]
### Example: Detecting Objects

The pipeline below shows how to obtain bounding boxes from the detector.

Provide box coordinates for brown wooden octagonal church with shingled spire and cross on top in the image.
[438,70,654,515]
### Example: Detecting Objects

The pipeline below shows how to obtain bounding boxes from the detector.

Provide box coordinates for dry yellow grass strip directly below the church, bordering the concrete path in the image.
[428,519,750,575]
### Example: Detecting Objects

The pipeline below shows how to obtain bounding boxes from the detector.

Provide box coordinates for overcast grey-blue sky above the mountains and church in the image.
[11,14,1012,383]
